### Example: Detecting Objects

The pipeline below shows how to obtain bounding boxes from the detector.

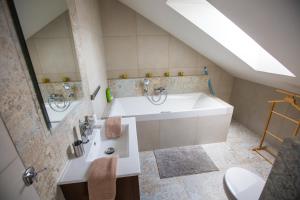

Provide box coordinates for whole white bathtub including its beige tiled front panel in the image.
[104,93,233,151]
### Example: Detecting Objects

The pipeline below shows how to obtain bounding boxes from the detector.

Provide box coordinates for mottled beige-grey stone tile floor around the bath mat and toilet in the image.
[139,122,271,200]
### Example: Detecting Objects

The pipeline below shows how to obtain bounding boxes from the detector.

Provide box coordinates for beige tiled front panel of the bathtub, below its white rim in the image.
[137,113,232,151]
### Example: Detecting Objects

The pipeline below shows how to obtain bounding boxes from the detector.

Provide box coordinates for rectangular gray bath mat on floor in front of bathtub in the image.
[154,146,219,178]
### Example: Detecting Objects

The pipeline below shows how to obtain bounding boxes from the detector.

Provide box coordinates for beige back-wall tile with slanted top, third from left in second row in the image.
[169,37,198,68]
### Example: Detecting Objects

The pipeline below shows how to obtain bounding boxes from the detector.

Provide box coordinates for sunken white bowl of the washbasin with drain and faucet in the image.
[86,124,129,162]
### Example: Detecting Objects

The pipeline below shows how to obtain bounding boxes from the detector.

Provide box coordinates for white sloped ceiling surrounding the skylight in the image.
[119,0,300,93]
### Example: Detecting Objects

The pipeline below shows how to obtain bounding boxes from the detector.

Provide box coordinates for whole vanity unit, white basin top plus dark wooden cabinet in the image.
[58,117,141,200]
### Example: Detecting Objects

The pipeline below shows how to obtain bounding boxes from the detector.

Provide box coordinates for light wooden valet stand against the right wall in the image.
[253,90,300,164]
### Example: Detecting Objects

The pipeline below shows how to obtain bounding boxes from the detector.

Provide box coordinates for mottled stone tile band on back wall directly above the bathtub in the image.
[108,75,209,97]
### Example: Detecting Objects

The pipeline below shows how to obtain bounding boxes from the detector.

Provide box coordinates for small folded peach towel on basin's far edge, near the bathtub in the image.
[105,117,122,139]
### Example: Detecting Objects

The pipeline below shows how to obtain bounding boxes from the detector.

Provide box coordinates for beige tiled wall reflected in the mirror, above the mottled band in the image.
[27,12,81,81]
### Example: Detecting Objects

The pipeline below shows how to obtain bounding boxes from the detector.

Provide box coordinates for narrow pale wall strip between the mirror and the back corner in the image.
[69,0,107,115]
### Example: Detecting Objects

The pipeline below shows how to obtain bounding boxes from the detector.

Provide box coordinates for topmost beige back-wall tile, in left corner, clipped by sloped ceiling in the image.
[101,0,136,36]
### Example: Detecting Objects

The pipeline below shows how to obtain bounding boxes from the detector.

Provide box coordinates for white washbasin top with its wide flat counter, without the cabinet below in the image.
[58,117,141,185]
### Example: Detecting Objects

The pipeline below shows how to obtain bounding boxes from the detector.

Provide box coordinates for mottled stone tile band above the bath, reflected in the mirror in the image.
[39,82,83,102]
